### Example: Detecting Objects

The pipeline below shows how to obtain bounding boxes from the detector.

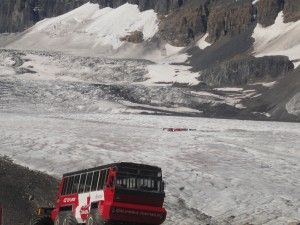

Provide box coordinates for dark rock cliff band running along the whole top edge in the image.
[0,0,300,42]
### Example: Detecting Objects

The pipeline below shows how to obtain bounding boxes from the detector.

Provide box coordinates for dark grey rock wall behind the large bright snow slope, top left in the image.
[0,0,183,33]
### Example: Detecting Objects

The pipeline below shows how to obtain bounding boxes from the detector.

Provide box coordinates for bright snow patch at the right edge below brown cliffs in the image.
[252,12,300,67]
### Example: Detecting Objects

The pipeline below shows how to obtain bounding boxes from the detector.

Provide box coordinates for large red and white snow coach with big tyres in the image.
[31,163,166,225]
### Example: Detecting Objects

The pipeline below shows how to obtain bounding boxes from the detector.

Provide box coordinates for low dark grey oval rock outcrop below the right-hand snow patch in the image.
[199,56,294,87]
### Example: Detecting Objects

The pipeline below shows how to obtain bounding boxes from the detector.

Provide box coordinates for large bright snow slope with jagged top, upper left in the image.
[7,3,158,51]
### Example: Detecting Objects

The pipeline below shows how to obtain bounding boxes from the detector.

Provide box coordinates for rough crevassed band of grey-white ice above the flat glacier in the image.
[0,51,268,115]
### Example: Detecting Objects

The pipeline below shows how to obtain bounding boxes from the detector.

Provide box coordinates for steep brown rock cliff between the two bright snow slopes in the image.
[160,0,256,46]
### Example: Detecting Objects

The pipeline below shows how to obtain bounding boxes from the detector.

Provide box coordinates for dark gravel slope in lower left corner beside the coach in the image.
[0,157,58,225]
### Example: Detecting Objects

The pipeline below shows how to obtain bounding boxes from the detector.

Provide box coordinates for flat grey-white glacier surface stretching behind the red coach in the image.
[0,113,300,225]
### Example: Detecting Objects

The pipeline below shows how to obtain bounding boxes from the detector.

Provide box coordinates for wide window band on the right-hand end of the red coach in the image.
[116,176,163,192]
